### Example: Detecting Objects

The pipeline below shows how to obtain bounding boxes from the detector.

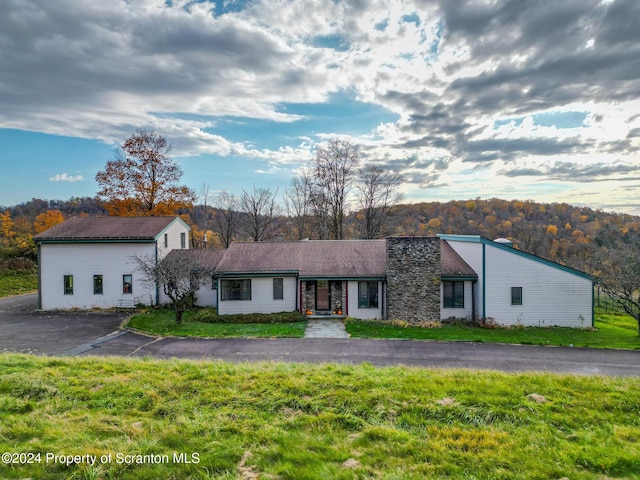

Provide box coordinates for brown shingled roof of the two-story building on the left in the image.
[34,217,177,242]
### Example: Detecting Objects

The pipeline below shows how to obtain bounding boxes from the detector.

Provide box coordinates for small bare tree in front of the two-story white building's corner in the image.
[133,250,213,325]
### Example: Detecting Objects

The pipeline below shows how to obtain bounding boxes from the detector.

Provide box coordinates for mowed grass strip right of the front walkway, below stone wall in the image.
[346,312,640,350]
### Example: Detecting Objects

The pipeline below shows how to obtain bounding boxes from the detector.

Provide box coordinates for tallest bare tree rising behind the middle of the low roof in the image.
[312,139,360,240]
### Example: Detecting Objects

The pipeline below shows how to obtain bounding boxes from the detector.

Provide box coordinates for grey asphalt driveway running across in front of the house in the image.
[0,295,640,376]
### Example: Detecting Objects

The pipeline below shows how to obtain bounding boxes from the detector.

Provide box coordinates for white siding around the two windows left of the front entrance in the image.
[217,277,298,315]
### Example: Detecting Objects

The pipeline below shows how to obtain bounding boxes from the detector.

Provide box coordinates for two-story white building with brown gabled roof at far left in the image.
[34,217,190,310]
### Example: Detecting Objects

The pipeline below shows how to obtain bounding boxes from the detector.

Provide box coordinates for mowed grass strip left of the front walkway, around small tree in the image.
[127,309,307,338]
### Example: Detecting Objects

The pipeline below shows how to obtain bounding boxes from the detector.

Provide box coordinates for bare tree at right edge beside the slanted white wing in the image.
[593,244,640,335]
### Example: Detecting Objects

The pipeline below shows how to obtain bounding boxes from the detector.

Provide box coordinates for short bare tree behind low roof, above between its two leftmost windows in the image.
[240,185,279,242]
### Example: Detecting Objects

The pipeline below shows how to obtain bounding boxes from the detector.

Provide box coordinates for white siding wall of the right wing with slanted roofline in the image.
[485,245,592,327]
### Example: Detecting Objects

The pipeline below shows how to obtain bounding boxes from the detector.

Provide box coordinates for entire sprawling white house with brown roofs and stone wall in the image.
[35,217,593,327]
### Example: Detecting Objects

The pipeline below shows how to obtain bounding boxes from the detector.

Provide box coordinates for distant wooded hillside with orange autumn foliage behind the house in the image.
[0,197,640,269]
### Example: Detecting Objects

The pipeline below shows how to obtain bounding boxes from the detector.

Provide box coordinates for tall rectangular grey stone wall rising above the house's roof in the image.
[386,237,440,323]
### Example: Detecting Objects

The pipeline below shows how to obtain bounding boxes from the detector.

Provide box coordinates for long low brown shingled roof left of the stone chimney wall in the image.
[217,240,386,278]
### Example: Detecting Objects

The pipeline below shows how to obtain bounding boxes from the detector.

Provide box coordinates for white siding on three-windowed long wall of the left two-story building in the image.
[40,243,156,310]
